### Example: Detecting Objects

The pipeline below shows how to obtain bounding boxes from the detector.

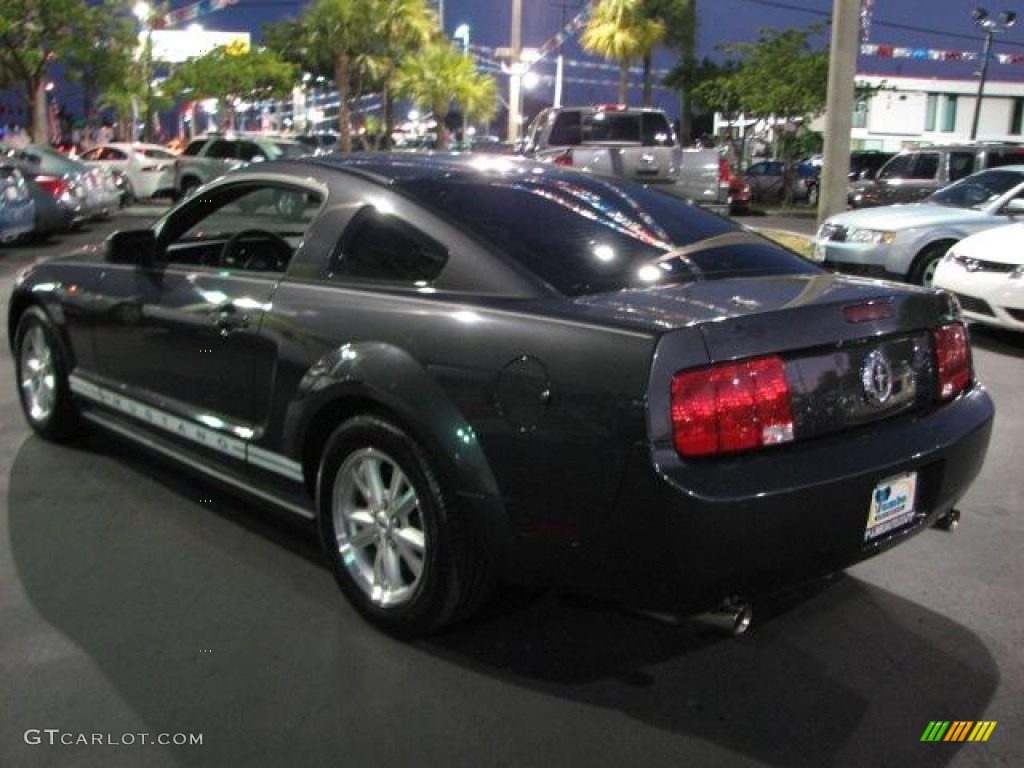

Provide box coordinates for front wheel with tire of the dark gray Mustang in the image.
[14,306,80,442]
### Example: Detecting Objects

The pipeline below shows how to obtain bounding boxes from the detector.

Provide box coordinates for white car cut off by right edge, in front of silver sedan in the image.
[932,223,1024,331]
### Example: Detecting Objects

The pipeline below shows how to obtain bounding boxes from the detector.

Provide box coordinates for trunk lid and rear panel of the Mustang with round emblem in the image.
[578,274,957,440]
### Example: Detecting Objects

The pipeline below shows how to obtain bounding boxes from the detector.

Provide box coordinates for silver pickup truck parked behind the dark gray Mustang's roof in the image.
[524,104,730,211]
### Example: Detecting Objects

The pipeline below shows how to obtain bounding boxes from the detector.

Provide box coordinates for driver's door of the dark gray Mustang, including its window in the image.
[93,180,321,435]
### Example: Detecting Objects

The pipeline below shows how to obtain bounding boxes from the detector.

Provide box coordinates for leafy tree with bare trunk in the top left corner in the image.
[0,0,99,142]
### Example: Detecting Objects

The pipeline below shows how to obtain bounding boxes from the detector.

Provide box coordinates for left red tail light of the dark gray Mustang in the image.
[672,357,794,456]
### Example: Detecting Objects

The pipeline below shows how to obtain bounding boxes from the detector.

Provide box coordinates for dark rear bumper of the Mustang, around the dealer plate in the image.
[581,388,994,611]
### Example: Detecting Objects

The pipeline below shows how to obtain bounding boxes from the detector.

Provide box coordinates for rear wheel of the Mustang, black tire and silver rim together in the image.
[316,415,493,637]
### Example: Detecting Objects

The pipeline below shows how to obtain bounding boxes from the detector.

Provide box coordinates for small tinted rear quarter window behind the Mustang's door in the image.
[331,207,447,285]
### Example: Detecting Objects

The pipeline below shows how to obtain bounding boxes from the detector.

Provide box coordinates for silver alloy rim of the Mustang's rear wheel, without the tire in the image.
[331,447,427,607]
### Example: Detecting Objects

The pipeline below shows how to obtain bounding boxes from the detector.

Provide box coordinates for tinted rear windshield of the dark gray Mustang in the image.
[400,173,818,296]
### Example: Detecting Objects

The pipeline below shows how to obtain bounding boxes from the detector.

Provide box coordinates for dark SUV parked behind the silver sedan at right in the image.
[849,143,1024,208]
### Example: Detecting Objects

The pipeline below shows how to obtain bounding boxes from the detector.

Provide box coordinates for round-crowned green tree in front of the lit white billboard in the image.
[163,45,296,132]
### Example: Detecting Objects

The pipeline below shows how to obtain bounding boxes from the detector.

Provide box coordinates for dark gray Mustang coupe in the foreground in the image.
[8,155,993,635]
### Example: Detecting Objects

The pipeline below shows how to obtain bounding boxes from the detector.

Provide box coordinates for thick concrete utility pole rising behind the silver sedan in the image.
[818,0,860,223]
